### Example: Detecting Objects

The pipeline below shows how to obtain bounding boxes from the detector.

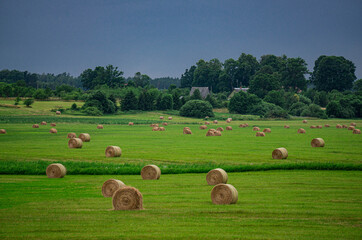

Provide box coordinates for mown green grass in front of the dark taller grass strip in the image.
[0,171,362,240]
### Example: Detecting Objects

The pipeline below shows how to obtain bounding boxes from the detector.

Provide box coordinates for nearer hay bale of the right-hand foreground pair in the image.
[211,183,238,205]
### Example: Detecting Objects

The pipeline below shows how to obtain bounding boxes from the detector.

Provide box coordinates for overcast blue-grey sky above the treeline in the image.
[0,0,362,78]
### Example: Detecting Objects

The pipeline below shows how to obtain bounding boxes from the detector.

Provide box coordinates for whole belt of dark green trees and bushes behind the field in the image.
[0,53,362,118]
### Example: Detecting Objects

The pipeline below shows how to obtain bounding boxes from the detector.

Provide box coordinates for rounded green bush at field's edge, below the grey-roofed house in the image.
[180,100,214,118]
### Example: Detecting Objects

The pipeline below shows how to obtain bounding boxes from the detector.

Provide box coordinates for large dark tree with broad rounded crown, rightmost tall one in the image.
[310,55,356,92]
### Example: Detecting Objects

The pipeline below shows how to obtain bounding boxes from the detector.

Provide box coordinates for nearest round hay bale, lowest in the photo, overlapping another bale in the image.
[112,186,143,210]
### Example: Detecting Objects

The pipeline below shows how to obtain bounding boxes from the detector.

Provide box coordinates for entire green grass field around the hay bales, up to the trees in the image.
[0,100,362,239]
